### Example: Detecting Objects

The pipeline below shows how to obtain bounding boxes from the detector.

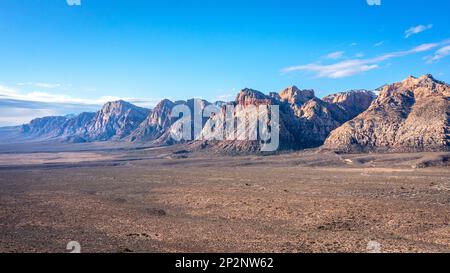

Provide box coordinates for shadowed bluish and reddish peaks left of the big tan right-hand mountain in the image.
[16,83,373,153]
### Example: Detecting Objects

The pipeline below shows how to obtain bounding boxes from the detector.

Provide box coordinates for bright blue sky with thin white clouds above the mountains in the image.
[0,0,450,126]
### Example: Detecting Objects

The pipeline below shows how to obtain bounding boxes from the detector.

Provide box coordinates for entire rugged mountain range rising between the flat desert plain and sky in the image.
[14,75,450,153]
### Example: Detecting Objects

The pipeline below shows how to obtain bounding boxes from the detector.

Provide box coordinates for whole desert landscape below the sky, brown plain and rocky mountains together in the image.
[0,75,450,252]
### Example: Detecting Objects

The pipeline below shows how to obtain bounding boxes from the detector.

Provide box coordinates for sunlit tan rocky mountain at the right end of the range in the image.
[325,75,450,151]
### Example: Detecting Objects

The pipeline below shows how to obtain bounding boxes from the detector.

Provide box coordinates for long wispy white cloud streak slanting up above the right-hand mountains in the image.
[282,41,447,79]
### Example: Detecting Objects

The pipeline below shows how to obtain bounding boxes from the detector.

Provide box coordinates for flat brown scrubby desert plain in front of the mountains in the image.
[0,141,450,252]
